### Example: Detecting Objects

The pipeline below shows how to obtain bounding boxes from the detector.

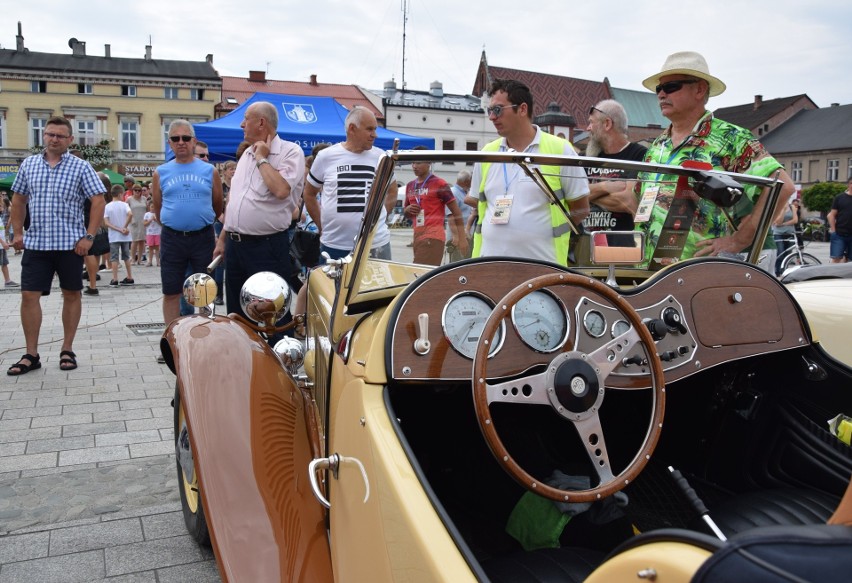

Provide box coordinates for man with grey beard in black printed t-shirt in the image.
[583,99,647,231]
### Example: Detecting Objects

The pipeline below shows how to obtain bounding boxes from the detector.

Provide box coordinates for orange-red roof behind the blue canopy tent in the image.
[216,72,384,125]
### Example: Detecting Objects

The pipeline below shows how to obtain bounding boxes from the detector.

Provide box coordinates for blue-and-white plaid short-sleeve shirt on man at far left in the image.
[12,152,104,251]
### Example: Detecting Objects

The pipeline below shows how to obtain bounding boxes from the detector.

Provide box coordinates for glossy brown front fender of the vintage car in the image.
[161,316,333,581]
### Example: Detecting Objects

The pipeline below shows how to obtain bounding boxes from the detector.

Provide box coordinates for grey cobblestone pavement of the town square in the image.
[0,229,828,583]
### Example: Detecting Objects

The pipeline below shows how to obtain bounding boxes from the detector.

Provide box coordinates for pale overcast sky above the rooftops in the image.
[6,0,852,109]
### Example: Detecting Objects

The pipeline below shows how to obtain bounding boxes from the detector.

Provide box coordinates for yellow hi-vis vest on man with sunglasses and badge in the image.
[471,132,571,266]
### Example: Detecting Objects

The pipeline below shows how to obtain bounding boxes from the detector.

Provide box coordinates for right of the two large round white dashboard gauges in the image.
[512,290,568,352]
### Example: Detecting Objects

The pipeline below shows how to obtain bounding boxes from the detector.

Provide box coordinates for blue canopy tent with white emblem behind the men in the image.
[191,93,435,162]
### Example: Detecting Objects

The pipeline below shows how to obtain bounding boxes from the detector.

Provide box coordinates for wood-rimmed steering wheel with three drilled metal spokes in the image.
[472,273,665,502]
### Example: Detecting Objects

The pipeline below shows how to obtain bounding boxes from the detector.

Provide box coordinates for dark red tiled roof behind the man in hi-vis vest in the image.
[473,51,612,129]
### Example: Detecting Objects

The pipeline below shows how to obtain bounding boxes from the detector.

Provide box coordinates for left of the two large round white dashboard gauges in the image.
[441,293,505,359]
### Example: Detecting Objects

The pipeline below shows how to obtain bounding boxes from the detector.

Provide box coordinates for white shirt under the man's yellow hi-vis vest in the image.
[471,126,589,263]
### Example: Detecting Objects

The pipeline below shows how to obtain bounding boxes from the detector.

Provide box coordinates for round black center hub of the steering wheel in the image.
[546,352,604,420]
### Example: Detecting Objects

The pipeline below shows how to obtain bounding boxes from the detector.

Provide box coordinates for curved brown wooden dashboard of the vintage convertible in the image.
[387,259,811,388]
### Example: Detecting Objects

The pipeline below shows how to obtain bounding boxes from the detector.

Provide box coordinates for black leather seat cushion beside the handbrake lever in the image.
[690,488,840,537]
